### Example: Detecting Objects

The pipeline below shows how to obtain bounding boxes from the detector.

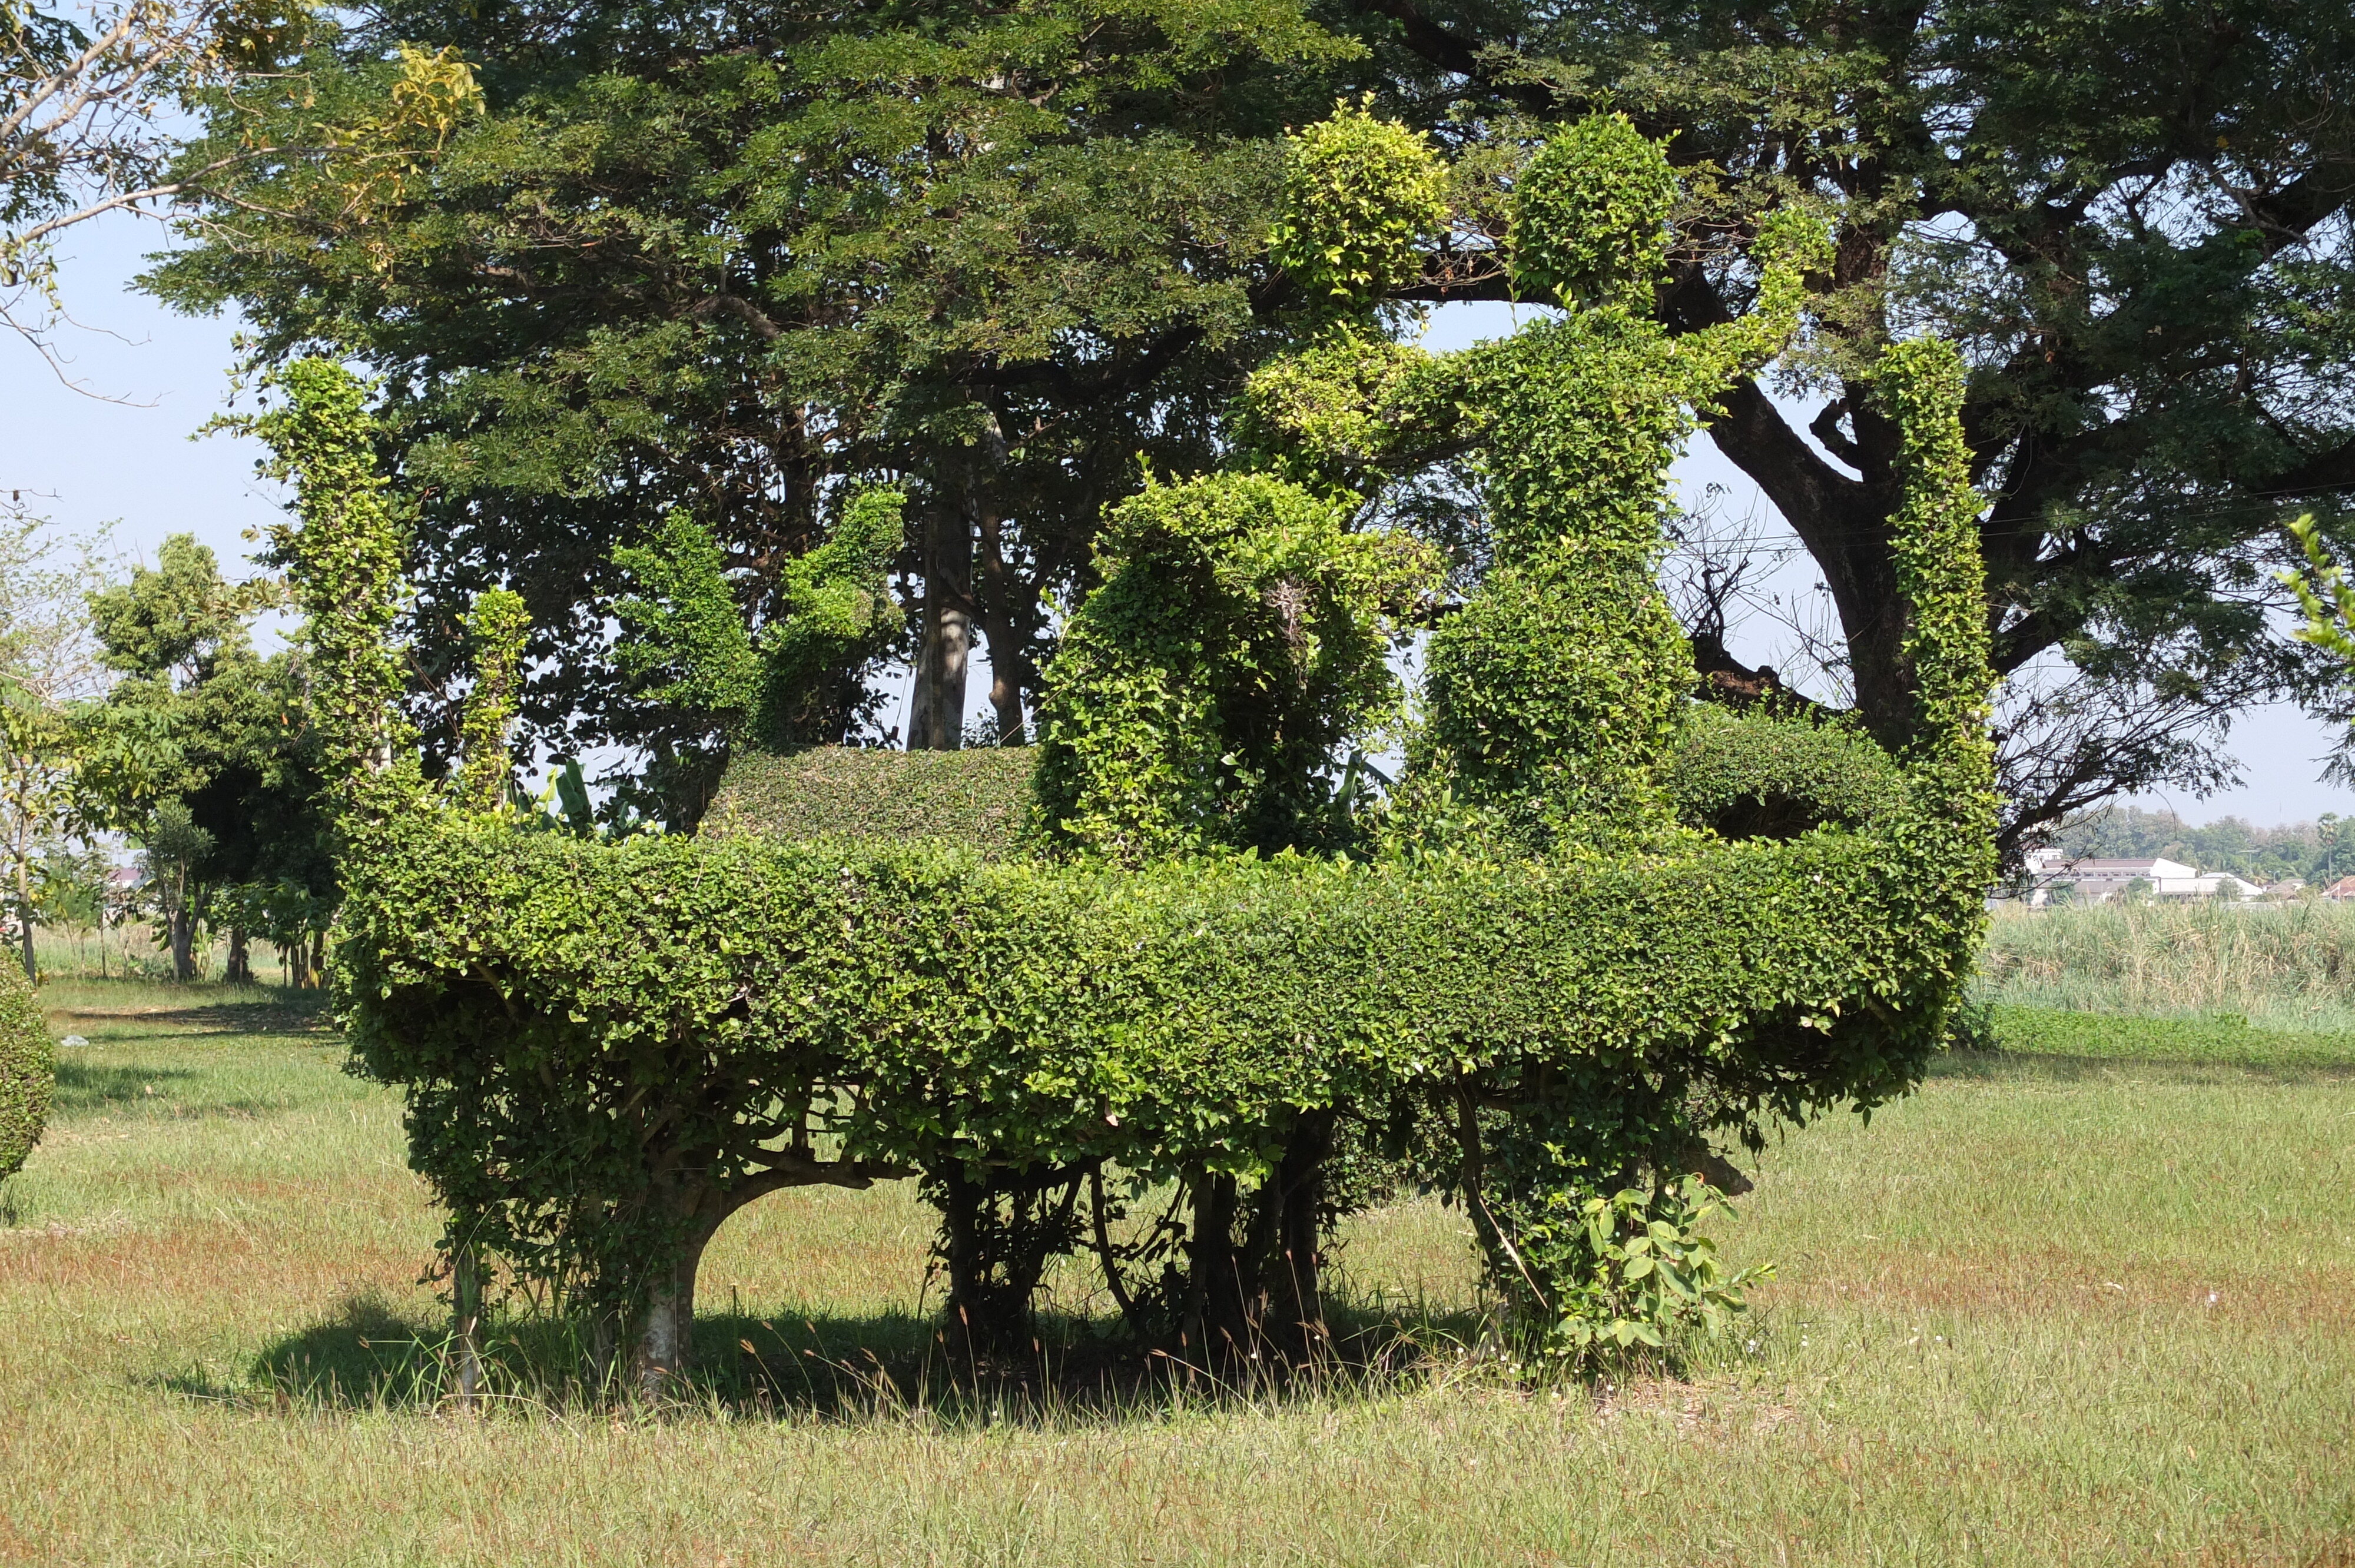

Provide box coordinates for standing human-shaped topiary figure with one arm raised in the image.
[1243,115,1825,852]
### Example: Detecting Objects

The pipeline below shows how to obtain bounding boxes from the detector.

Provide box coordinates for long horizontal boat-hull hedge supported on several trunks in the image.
[339,753,1981,1316]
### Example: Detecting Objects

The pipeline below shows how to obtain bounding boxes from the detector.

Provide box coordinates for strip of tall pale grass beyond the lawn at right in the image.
[1981,902,2355,1031]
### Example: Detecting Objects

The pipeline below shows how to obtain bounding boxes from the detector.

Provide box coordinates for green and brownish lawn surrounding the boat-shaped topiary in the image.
[0,984,2355,1568]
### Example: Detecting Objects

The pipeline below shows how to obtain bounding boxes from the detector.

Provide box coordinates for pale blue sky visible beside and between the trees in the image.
[0,217,2355,824]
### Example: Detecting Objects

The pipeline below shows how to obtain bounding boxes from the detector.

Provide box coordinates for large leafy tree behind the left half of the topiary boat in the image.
[158,0,1359,815]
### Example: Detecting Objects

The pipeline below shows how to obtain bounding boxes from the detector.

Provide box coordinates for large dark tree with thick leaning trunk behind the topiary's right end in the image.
[1349,0,2355,843]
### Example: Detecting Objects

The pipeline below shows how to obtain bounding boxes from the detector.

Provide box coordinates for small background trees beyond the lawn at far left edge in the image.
[0,518,337,984]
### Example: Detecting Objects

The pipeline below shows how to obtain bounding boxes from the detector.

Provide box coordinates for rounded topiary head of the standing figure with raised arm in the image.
[1512,115,1677,306]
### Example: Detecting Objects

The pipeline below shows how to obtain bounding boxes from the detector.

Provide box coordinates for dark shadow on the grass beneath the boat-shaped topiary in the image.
[207,1295,1477,1424]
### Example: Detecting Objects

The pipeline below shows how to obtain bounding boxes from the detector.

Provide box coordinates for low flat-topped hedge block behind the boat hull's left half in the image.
[702,746,1036,859]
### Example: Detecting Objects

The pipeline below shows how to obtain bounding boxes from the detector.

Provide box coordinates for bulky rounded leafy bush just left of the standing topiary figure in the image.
[1039,473,1439,864]
